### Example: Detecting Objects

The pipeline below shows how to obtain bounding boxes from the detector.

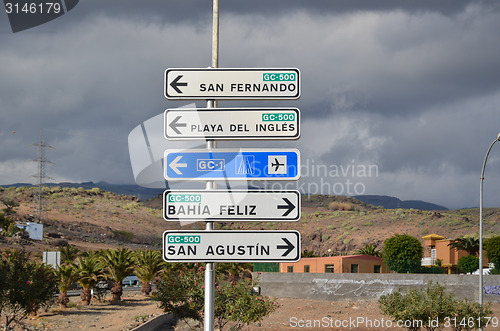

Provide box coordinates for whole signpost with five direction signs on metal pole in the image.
[163,4,301,331]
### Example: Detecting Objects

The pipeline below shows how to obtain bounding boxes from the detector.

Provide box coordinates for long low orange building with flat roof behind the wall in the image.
[280,255,389,273]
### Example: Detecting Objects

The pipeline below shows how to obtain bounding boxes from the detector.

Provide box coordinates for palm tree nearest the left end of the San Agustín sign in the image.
[134,249,165,295]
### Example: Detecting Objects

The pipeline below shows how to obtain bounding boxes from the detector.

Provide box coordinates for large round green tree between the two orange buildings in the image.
[382,234,424,273]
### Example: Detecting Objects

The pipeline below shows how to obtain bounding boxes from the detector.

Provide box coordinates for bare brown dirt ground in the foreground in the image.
[16,292,500,331]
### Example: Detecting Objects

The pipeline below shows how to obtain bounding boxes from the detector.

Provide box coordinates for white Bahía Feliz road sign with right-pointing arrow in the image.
[163,190,300,221]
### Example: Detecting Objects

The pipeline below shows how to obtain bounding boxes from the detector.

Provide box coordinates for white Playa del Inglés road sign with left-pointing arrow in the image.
[165,108,300,140]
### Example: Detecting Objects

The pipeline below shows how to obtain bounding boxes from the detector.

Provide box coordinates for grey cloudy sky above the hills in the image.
[0,0,500,208]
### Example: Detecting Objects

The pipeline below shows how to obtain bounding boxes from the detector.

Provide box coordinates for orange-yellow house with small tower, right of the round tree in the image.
[422,233,488,273]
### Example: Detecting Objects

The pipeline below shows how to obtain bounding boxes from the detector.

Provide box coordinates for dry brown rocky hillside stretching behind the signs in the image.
[0,187,500,254]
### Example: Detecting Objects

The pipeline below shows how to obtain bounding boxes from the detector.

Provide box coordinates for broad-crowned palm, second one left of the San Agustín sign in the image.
[101,248,134,302]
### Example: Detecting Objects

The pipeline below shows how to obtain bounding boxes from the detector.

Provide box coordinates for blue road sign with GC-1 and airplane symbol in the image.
[165,148,300,181]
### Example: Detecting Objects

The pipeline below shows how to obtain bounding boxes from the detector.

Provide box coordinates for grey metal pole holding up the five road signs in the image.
[203,0,219,331]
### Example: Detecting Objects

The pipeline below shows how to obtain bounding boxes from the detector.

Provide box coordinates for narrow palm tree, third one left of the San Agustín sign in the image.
[77,254,102,305]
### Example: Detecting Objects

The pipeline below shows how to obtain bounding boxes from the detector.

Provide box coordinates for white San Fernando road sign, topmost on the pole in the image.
[165,68,300,100]
